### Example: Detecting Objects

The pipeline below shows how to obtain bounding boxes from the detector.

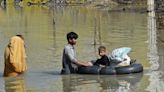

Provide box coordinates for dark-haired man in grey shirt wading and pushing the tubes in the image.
[61,32,92,74]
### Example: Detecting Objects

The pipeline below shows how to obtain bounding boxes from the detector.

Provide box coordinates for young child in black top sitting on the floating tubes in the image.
[93,46,110,67]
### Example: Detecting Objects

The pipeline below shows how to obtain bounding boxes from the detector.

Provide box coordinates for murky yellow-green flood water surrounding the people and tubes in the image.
[0,2,164,92]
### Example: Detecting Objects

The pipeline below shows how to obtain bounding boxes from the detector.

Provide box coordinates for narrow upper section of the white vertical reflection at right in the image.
[148,0,159,70]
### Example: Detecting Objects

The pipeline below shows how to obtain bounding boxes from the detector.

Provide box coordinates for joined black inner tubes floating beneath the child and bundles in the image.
[77,63,143,75]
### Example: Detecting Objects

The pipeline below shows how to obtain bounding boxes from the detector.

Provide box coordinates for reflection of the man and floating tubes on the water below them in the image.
[62,73,143,92]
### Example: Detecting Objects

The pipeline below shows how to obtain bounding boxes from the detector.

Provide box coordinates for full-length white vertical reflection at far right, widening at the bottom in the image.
[146,0,164,92]
